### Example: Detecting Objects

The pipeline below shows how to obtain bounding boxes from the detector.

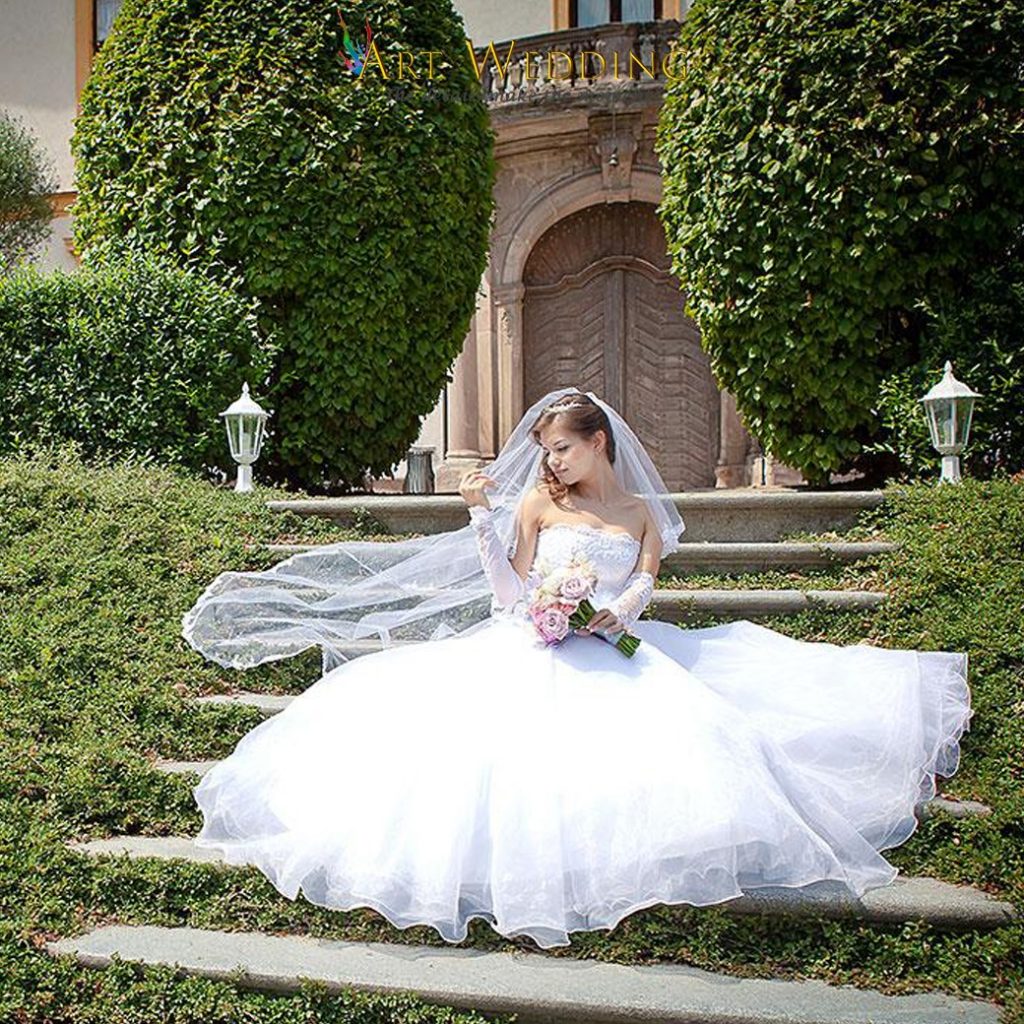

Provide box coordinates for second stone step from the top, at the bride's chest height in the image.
[256,541,896,575]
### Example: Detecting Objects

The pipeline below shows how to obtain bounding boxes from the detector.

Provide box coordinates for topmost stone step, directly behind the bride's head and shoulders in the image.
[267,487,885,544]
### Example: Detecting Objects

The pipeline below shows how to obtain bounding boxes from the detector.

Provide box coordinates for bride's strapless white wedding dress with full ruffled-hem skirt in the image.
[194,524,972,947]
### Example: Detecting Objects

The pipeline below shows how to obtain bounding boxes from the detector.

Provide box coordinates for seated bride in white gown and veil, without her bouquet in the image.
[183,387,972,948]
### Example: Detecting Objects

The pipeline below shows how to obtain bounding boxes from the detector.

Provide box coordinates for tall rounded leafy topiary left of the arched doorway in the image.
[73,0,495,490]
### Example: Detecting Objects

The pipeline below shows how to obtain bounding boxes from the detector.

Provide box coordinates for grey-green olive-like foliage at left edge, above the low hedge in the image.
[0,109,56,275]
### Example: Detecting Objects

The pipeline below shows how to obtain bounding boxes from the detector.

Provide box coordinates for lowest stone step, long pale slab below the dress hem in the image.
[45,925,999,1024]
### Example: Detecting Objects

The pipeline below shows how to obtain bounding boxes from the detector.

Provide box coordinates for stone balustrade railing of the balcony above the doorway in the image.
[475,19,679,104]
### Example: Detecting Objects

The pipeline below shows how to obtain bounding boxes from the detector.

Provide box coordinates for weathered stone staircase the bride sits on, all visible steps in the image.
[46,490,1018,1024]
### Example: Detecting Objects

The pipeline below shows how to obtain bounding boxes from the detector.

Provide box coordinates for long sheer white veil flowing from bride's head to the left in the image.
[181,387,684,674]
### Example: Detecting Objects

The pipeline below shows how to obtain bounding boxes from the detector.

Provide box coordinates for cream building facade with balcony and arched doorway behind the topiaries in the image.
[0,0,801,492]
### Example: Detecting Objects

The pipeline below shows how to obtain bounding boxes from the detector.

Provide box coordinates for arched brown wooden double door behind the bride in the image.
[522,202,721,490]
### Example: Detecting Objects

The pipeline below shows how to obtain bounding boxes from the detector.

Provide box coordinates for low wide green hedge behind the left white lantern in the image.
[0,256,274,470]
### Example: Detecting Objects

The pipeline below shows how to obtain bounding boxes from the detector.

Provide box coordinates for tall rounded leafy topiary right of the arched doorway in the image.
[656,0,1024,481]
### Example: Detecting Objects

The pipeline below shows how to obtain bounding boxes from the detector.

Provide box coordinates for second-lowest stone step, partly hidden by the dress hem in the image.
[68,836,1017,929]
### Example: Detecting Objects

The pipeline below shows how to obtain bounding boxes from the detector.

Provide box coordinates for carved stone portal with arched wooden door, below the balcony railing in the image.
[391,78,774,492]
